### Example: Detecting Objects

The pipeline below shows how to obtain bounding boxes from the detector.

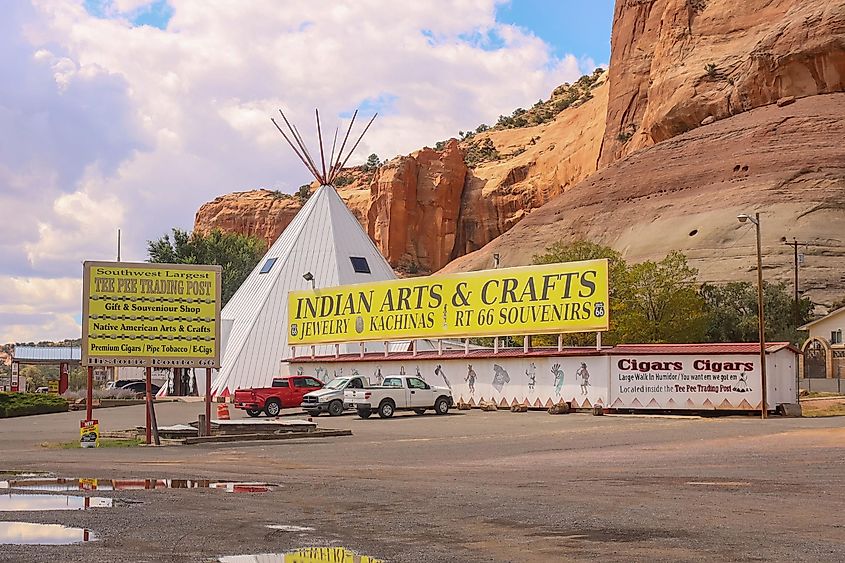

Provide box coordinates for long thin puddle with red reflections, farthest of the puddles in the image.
[0,479,278,493]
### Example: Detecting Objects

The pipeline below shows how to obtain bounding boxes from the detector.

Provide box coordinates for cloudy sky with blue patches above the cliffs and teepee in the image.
[0,0,613,343]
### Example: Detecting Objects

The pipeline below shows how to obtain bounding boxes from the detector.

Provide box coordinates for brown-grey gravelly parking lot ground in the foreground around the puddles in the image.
[0,403,845,562]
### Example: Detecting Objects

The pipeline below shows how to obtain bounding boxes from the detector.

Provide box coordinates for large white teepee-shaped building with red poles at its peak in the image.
[212,107,396,397]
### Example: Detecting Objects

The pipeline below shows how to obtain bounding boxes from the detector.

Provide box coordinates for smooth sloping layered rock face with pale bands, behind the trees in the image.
[443,94,845,303]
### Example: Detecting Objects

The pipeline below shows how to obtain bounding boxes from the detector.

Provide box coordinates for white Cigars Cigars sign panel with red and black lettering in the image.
[610,355,761,409]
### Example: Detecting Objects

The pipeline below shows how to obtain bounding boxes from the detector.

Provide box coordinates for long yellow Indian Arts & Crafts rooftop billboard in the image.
[288,260,609,344]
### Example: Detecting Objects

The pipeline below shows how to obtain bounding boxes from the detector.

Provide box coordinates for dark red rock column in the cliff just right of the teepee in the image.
[366,139,467,271]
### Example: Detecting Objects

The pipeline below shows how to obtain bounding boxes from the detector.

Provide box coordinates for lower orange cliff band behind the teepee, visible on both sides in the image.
[194,78,608,273]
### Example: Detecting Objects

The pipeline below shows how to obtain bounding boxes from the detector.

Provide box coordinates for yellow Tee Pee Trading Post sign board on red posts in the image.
[82,262,221,368]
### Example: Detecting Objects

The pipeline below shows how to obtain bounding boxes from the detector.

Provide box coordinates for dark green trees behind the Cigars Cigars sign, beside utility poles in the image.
[700,282,813,344]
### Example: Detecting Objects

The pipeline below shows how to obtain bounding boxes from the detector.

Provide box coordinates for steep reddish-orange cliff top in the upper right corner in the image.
[600,0,845,166]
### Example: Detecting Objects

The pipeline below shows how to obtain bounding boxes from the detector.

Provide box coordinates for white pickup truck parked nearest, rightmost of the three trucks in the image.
[344,375,452,418]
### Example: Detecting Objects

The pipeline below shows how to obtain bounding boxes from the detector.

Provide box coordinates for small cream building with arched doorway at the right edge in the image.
[798,307,845,392]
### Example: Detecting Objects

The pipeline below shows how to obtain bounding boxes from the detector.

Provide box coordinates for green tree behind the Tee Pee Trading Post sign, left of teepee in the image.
[147,229,267,305]
